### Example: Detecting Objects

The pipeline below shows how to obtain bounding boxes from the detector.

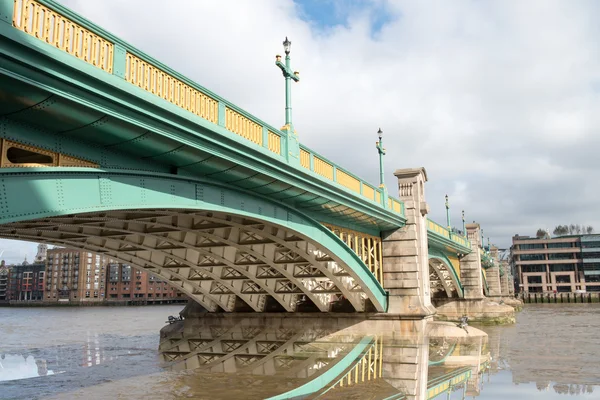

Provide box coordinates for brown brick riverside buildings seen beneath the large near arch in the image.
[44,248,184,303]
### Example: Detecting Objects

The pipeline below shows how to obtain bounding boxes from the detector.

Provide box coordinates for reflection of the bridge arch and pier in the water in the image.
[159,316,490,400]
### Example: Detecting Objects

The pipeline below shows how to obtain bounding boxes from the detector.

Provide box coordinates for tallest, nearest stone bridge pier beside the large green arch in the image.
[383,168,435,318]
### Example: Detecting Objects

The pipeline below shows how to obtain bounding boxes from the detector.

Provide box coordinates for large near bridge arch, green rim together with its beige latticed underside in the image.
[0,167,387,312]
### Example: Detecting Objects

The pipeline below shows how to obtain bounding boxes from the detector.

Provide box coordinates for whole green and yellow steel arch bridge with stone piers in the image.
[0,0,512,317]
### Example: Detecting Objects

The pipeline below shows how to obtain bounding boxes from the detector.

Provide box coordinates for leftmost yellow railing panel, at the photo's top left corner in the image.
[13,0,114,73]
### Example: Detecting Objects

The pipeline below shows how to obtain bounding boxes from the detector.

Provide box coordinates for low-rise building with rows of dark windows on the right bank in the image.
[511,231,600,293]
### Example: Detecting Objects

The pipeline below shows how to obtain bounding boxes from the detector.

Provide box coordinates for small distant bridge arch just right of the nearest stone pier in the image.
[429,248,463,298]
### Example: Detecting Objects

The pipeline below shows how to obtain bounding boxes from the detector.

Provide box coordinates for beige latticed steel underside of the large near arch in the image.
[0,209,380,312]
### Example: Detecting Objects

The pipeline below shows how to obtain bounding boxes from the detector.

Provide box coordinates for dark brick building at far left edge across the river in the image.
[6,260,46,301]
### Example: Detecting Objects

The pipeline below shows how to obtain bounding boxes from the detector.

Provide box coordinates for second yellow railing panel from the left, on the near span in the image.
[125,53,219,124]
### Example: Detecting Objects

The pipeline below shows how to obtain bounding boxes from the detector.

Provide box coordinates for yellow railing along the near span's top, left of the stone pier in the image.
[4,0,404,219]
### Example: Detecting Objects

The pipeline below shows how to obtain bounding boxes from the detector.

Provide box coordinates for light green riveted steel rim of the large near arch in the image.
[0,167,387,311]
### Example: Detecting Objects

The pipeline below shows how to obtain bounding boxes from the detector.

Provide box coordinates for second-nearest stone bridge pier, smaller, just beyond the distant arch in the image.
[460,223,484,299]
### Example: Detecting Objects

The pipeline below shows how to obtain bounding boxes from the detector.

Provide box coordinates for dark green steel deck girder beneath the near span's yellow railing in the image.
[0,7,405,234]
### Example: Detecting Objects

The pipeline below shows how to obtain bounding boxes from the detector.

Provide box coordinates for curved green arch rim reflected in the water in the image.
[267,336,374,400]
